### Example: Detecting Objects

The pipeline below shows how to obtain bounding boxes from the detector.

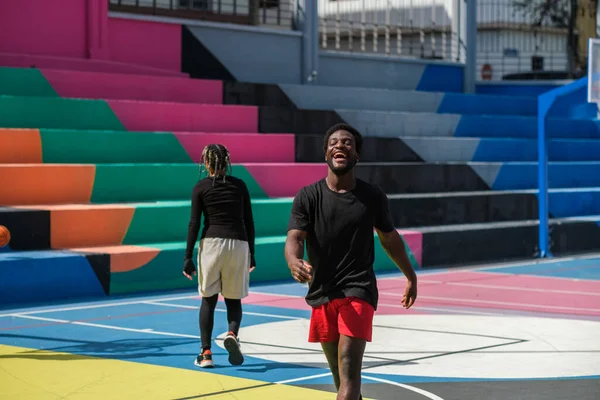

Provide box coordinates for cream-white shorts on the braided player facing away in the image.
[198,238,250,299]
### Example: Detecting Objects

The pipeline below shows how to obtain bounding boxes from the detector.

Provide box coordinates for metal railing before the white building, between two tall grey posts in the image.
[319,0,465,61]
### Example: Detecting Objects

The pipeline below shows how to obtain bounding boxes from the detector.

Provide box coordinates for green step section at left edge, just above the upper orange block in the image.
[0,96,125,131]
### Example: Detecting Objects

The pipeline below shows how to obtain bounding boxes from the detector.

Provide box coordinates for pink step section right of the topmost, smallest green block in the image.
[40,69,223,104]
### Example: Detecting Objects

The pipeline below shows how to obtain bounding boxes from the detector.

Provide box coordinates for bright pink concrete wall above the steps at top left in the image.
[0,0,181,73]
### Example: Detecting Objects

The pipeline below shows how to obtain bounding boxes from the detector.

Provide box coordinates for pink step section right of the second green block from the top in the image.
[106,100,258,133]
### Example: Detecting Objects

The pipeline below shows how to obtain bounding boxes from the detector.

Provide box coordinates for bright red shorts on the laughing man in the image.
[308,297,375,343]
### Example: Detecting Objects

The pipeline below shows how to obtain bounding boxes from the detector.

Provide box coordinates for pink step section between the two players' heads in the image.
[244,162,327,197]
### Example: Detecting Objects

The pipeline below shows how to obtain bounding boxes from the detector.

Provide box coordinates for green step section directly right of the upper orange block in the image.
[40,129,192,164]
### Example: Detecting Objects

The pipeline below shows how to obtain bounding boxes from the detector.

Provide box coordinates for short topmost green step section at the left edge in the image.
[0,67,58,97]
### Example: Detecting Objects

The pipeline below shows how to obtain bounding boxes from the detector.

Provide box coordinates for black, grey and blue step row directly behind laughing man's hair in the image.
[259,106,600,139]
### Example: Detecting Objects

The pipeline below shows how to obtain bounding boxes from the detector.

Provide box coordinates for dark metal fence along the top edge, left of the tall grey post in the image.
[108,0,298,29]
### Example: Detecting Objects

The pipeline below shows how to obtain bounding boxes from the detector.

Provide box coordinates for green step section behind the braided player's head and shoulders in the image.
[91,164,267,203]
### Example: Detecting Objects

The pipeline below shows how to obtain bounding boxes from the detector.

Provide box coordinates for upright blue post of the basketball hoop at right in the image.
[538,94,555,258]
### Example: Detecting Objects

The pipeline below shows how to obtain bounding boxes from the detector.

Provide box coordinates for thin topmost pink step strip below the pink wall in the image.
[0,53,189,77]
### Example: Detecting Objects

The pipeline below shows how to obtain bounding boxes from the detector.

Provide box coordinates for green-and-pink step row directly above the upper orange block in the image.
[0,96,258,133]
